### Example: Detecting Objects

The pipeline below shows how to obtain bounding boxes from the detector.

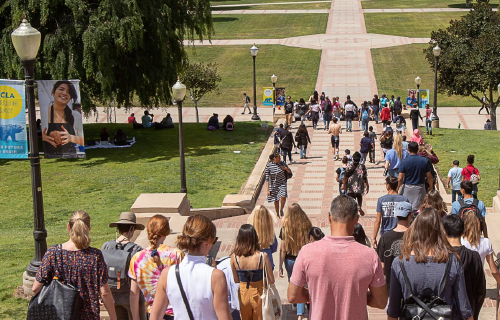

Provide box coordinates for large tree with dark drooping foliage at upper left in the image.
[0,0,213,111]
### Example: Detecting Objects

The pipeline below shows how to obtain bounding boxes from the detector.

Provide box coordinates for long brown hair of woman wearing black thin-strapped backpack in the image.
[400,208,458,263]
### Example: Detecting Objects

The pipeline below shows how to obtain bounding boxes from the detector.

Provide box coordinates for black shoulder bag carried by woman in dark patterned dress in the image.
[26,245,81,320]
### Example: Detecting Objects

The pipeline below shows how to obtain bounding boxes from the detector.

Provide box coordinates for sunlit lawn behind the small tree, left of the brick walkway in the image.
[185,45,321,107]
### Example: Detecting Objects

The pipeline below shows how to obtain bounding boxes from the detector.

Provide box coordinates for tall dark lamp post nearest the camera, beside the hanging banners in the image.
[11,18,47,293]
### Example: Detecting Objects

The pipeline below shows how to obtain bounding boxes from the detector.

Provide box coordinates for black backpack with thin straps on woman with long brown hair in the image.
[399,254,453,320]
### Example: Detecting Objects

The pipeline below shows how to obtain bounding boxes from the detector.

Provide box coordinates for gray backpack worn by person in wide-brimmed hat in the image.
[102,241,138,293]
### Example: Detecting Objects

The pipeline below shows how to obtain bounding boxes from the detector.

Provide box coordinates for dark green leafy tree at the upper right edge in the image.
[424,1,500,130]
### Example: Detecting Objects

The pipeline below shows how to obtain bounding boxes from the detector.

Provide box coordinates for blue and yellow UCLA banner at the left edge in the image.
[0,80,27,159]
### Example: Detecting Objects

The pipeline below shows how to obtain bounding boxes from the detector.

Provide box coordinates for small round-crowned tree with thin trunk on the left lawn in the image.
[181,62,222,123]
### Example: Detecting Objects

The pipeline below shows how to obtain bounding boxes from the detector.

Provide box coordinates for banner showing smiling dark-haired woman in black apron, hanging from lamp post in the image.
[37,80,85,158]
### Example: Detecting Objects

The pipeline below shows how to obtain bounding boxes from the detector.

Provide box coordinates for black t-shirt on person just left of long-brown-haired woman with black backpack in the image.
[377,230,405,288]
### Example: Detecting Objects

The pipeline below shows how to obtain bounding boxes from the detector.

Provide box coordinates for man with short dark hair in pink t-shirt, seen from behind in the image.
[288,195,387,320]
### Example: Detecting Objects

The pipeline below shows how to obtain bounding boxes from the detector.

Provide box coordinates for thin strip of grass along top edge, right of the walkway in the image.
[361,0,498,9]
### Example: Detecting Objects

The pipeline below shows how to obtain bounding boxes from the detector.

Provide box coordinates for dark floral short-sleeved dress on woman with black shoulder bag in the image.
[36,245,108,320]
